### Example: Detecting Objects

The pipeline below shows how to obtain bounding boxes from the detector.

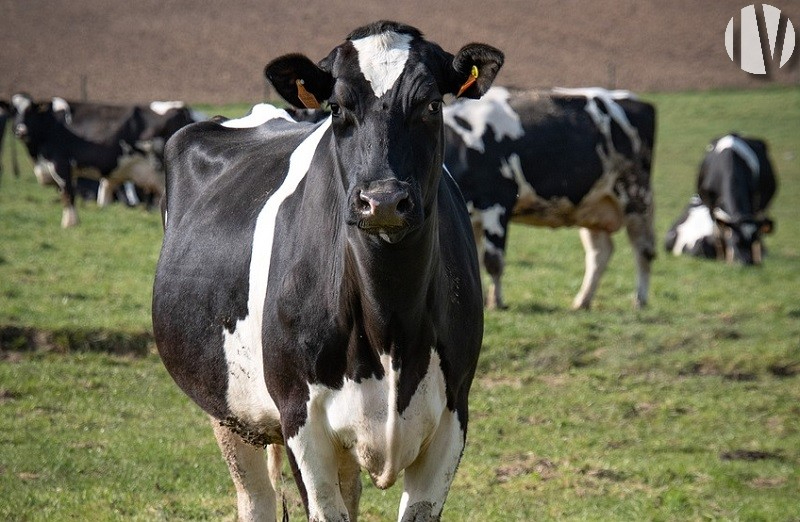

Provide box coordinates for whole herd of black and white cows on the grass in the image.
[2,22,776,520]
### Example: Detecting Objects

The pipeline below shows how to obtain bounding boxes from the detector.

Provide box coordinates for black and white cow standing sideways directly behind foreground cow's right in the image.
[444,87,656,309]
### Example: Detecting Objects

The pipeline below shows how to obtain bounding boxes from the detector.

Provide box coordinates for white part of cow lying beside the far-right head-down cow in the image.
[664,194,717,258]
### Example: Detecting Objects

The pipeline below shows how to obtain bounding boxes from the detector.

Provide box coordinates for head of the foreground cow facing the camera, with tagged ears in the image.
[265,21,503,243]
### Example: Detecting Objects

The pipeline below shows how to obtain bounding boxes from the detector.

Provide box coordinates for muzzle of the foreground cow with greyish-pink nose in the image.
[352,179,414,243]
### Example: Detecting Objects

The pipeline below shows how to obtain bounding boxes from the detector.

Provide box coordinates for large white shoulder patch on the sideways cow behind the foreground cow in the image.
[442,87,525,152]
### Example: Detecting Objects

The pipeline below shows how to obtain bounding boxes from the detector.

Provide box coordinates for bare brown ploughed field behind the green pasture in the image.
[0,0,800,104]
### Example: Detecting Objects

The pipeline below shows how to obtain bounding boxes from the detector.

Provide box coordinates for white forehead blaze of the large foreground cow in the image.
[352,32,413,98]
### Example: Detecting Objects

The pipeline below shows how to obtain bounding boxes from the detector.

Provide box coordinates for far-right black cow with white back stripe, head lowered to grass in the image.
[697,134,778,265]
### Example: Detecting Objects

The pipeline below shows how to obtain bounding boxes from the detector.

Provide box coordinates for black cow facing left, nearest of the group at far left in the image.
[12,95,163,228]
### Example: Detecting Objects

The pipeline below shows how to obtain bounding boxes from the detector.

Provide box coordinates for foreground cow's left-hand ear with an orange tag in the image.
[264,54,333,109]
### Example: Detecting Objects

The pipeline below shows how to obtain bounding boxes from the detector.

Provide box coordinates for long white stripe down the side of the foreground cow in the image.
[222,118,331,424]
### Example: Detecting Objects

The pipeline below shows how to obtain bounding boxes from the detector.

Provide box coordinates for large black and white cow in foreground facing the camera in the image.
[153,22,503,520]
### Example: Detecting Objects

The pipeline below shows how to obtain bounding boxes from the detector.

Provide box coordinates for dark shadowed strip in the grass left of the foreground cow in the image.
[0,325,154,357]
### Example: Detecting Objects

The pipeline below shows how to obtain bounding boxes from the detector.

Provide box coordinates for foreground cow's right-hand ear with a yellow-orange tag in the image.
[445,43,505,98]
